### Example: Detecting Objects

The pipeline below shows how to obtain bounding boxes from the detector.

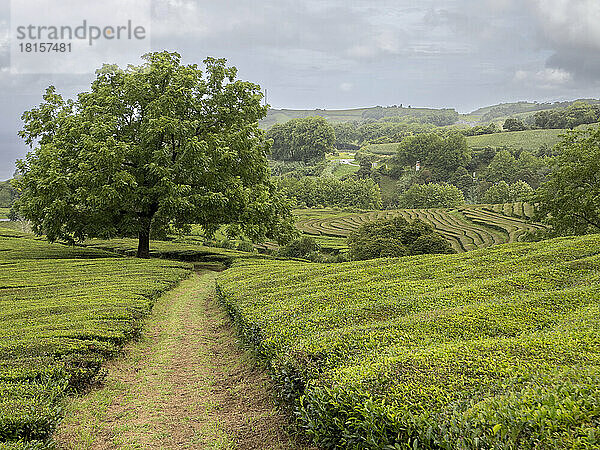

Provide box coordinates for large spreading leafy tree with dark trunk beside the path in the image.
[16,52,291,257]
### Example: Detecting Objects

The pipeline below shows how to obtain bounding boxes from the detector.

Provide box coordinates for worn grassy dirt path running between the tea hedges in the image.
[56,270,299,450]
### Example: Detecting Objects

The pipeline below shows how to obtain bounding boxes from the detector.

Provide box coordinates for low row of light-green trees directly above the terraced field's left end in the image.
[279,177,381,209]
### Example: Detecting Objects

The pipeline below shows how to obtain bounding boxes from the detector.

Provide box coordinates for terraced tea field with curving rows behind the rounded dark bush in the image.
[295,203,543,252]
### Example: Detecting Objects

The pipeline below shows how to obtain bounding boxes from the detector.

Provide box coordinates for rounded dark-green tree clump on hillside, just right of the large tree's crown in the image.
[267,117,335,163]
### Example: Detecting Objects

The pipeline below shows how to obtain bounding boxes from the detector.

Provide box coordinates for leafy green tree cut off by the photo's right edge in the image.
[535,128,600,235]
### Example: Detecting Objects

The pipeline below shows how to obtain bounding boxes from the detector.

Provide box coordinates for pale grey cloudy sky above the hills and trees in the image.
[0,0,600,180]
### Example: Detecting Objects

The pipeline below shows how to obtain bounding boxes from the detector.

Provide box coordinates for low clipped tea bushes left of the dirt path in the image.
[0,228,191,448]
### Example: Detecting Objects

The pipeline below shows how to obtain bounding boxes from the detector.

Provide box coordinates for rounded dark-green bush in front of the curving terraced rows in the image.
[348,216,455,260]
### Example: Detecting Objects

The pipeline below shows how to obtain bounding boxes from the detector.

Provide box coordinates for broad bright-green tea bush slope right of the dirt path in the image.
[218,235,600,449]
